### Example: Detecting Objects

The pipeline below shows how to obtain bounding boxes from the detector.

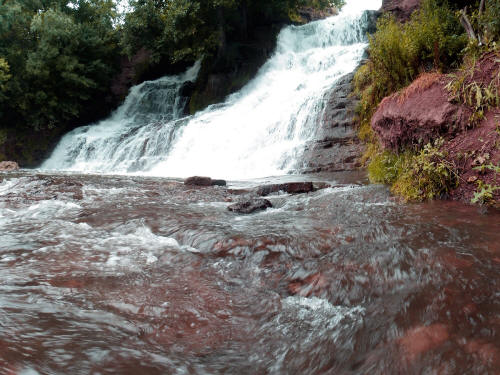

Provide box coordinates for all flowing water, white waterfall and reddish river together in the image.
[0,1,500,375]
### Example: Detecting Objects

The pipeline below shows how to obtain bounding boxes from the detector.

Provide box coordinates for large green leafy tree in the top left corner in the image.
[0,0,119,134]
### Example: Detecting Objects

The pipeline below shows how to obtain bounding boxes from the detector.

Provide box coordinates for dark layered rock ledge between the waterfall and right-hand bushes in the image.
[299,73,363,173]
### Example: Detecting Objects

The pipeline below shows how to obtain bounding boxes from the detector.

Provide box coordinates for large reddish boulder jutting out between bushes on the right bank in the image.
[371,73,472,151]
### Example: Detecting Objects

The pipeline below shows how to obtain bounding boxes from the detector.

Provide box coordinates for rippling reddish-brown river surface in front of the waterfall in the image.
[0,171,500,375]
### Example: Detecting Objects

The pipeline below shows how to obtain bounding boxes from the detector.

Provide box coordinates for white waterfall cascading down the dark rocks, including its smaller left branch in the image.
[42,0,381,179]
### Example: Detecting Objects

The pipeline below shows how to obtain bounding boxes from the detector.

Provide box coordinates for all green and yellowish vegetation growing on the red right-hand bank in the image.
[354,0,500,201]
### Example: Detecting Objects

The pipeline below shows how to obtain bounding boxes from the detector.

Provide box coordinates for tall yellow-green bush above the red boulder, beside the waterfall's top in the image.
[354,0,467,128]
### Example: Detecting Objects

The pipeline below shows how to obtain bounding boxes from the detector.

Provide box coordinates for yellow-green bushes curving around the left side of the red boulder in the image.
[354,0,467,201]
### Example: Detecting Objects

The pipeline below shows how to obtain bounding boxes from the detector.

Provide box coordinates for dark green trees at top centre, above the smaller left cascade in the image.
[121,0,342,63]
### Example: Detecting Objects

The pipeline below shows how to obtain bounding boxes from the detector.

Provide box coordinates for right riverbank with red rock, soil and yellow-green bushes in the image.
[355,0,500,207]
